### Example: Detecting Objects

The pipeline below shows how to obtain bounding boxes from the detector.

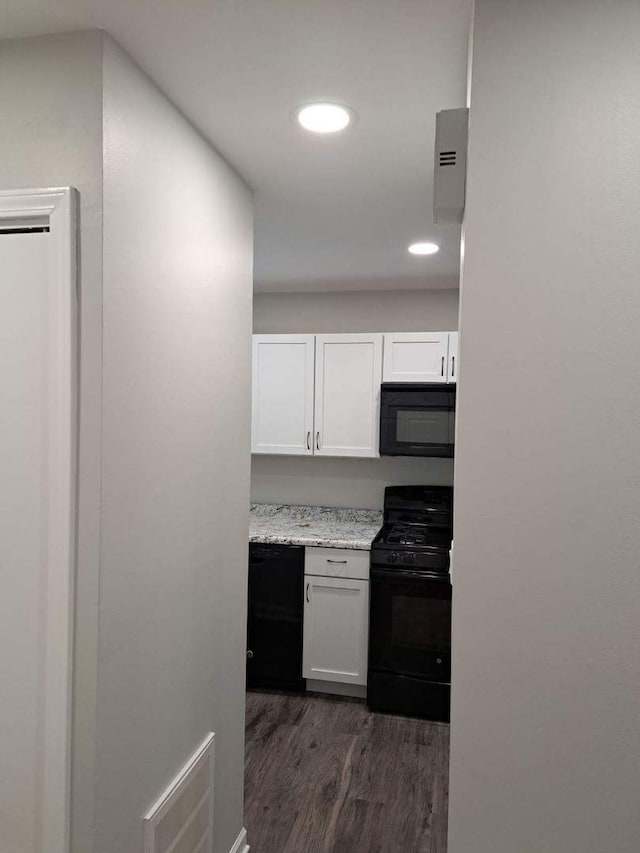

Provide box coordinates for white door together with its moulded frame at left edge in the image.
[0,191,74,853]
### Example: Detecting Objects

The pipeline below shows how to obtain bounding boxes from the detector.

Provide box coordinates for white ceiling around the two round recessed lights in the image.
[0,0,472,290]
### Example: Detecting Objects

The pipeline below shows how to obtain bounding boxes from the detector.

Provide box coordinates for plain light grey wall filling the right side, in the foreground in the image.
[449,0,640,853]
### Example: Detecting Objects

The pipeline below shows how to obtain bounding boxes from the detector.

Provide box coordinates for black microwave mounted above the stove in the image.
[380,382,456,458]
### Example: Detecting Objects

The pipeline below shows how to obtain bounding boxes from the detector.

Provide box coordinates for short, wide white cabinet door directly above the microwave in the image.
[383,332,449,382]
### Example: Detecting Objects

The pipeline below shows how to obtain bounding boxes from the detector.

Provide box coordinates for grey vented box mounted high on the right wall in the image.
[433,107,469,223]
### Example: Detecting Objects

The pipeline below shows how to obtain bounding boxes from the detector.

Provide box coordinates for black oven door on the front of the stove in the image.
[369,572,451,681]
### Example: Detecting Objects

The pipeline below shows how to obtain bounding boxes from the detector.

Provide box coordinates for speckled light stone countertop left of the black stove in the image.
[249,504,382,551]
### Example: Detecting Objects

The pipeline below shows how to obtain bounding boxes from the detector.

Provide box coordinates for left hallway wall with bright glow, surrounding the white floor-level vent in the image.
[95,38,252,853]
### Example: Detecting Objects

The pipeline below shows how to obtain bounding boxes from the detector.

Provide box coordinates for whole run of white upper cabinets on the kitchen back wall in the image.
[251,332,459,457]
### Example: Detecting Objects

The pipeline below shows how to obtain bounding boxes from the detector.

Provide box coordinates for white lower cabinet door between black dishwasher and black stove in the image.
[302,575,369,684]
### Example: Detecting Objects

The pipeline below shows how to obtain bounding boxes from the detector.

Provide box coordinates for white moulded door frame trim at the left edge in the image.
[0,187,77,853]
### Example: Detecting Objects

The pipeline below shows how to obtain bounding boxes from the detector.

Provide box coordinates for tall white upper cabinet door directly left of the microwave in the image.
[314,335,382,456]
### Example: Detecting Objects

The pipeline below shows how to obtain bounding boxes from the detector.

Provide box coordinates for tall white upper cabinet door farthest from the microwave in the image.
[251,335,315,456]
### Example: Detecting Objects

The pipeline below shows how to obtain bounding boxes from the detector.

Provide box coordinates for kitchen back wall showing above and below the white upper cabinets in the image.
[251,290,458,509]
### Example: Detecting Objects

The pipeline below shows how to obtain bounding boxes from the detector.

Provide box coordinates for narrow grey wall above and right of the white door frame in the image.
[0,32,102,853]
